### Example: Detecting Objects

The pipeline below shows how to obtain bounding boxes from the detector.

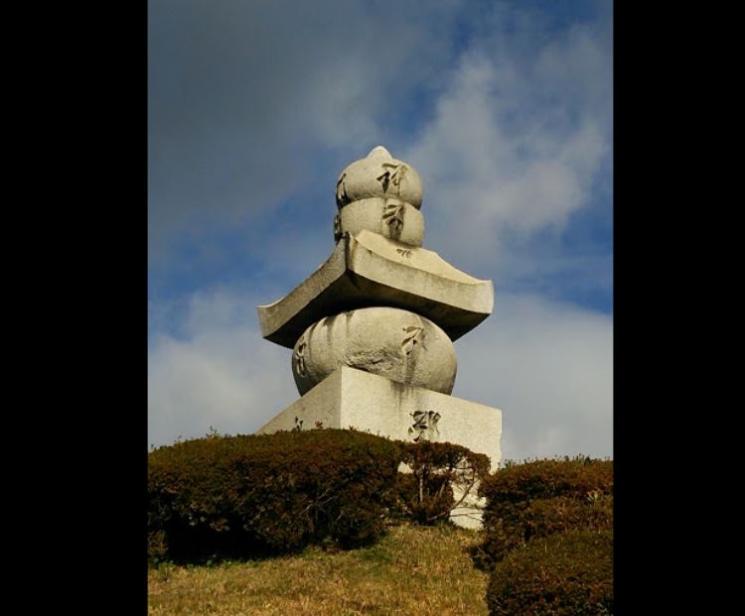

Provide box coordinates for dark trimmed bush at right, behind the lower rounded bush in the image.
[472,458,613,569]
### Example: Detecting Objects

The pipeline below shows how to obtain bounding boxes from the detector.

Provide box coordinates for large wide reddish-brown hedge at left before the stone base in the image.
[148,430,399,561]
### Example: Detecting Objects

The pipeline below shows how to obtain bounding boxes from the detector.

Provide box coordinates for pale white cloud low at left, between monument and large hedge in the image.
[148,290,297,445]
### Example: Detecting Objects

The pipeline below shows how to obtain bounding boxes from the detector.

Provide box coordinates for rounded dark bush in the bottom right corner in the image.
[486,531,613,616]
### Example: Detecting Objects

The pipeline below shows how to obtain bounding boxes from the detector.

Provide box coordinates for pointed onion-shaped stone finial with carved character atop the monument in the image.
[336,145,422,209]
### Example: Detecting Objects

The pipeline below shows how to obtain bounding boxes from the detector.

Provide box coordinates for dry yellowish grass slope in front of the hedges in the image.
[148,526,487,616]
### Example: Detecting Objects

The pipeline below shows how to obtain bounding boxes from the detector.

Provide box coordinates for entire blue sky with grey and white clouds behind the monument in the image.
[148,0,613,459]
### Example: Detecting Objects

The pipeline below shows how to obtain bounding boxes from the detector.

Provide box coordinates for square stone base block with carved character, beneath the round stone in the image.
[257,366,502,528]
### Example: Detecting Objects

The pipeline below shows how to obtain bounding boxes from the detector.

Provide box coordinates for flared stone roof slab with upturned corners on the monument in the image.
[257,230,494,348]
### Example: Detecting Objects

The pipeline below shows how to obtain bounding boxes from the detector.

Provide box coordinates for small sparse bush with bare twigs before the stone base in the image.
[398,441,489,525]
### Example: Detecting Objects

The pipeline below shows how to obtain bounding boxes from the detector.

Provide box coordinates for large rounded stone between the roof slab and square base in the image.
[292,307,457,395]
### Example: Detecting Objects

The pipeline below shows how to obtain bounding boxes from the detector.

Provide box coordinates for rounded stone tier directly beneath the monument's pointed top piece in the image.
[334,197,424,246]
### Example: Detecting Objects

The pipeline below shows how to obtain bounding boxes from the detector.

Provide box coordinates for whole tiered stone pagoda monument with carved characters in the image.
[258,146,502,526]
